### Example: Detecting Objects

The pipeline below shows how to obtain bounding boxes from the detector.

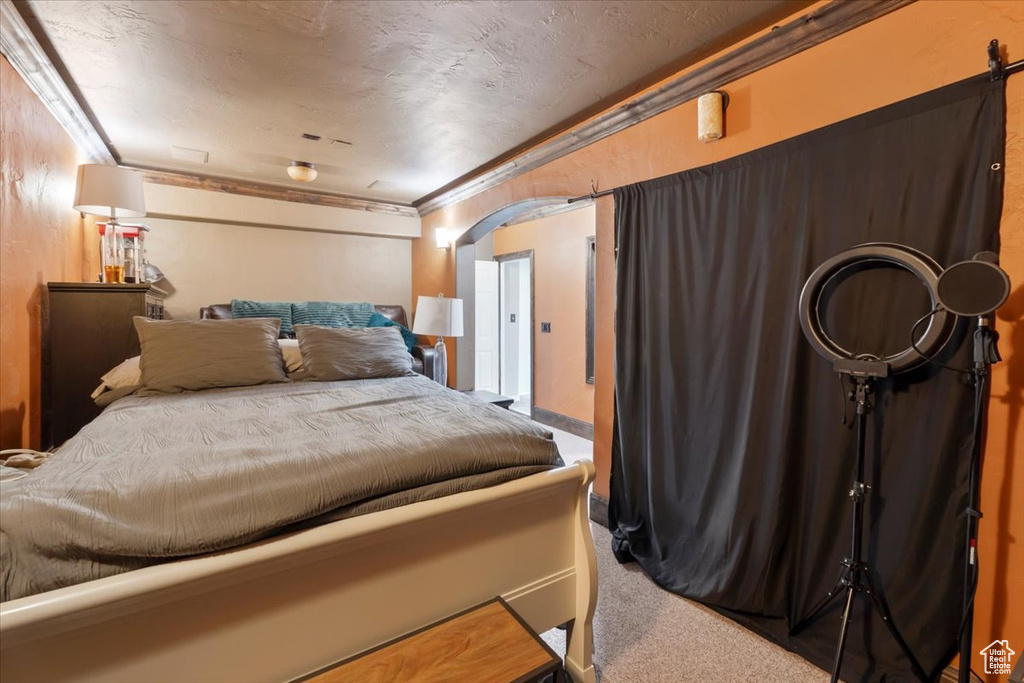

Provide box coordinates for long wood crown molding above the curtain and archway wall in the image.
[413,0,914,216]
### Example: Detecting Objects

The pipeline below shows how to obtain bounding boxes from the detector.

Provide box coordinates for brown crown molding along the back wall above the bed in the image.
[134,165,420,218]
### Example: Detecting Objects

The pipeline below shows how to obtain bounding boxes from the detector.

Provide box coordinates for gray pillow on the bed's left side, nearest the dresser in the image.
[134,316,288,395]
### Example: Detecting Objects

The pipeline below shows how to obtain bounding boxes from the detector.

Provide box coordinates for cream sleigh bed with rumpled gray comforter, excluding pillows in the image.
[0,362,597,683]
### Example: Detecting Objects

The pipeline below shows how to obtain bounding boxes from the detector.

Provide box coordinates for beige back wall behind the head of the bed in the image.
[142,183,420,318]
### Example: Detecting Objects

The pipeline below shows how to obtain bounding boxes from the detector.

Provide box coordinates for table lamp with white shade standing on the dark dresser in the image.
[75,164,145,283]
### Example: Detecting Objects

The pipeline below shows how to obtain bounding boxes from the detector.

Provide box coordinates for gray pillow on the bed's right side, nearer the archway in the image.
[295,325,413,381]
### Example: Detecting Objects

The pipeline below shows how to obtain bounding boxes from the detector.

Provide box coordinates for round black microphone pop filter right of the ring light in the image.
[935,252,1010,317]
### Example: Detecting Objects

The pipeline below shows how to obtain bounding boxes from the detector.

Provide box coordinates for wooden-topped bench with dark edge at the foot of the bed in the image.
[300,598,563,683]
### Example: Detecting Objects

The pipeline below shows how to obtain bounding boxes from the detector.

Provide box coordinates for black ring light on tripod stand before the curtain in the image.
[790,243,954,683]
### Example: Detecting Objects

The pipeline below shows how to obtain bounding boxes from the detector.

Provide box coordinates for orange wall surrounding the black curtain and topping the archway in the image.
[413,0,1024,680]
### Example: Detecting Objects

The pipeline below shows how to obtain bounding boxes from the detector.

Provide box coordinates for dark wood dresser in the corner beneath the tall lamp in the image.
[43,283,165,446]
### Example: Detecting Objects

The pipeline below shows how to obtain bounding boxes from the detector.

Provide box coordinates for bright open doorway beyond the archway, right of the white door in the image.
[497,251,534,416]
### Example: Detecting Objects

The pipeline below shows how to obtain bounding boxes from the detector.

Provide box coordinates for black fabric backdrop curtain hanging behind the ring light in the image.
[609,77,1005,681]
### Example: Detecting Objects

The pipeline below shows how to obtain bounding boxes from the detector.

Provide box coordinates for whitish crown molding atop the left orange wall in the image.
[0,0,117,164]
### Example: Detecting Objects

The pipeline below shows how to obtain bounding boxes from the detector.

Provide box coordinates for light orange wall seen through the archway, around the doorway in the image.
[494,207,596,423]
